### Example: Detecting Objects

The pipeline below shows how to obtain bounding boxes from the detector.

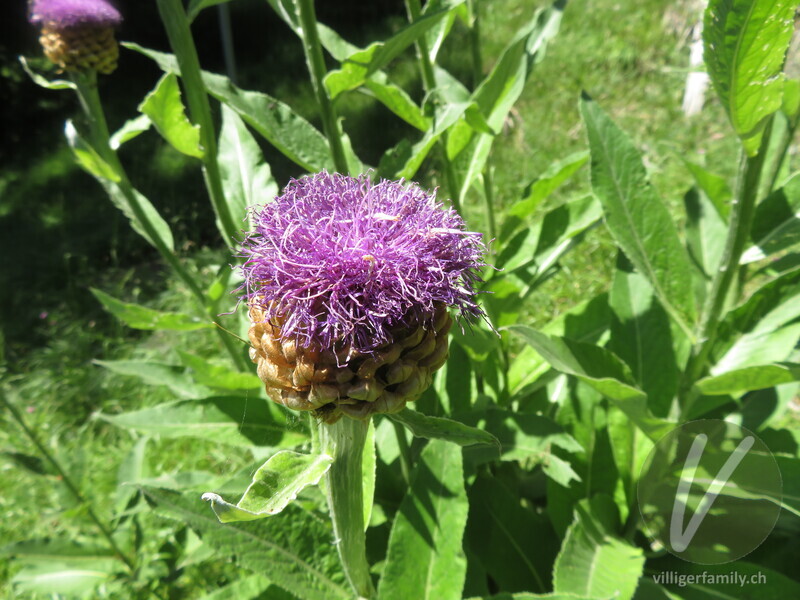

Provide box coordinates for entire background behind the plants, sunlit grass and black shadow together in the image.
[0,0,776,598]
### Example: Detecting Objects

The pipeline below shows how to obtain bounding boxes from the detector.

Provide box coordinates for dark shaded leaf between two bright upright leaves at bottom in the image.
[466,474,558,597]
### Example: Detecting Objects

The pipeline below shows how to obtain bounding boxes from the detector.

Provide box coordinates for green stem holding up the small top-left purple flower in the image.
[72,71,247,371]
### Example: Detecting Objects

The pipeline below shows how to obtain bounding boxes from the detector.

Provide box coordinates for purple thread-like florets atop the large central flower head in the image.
[241,171,486,352]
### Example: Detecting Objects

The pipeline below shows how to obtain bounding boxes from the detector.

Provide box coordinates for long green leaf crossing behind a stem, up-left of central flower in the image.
[123,43,334,171]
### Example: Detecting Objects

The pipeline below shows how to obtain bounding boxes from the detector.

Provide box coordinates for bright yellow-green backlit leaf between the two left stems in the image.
[139,73,204,158]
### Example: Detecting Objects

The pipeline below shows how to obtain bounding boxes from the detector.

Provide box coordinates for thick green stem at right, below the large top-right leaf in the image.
[680,120,772,412]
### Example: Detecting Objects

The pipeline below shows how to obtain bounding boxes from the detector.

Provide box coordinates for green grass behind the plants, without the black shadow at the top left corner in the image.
[0,0,776,598]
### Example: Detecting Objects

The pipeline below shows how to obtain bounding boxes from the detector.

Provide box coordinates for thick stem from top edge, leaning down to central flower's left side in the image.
[157,0,241,248]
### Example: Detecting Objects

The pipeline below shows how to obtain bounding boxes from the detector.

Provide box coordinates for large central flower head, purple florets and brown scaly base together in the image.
[242,172,485,423]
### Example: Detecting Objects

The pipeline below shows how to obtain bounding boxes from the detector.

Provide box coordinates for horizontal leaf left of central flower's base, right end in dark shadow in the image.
[100,396,307,448]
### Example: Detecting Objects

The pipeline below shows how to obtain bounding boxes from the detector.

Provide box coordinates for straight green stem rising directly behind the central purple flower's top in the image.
[297,0,350,175]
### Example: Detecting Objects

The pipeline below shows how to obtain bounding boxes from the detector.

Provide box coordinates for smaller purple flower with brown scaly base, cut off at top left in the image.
[28,0,122,74]
